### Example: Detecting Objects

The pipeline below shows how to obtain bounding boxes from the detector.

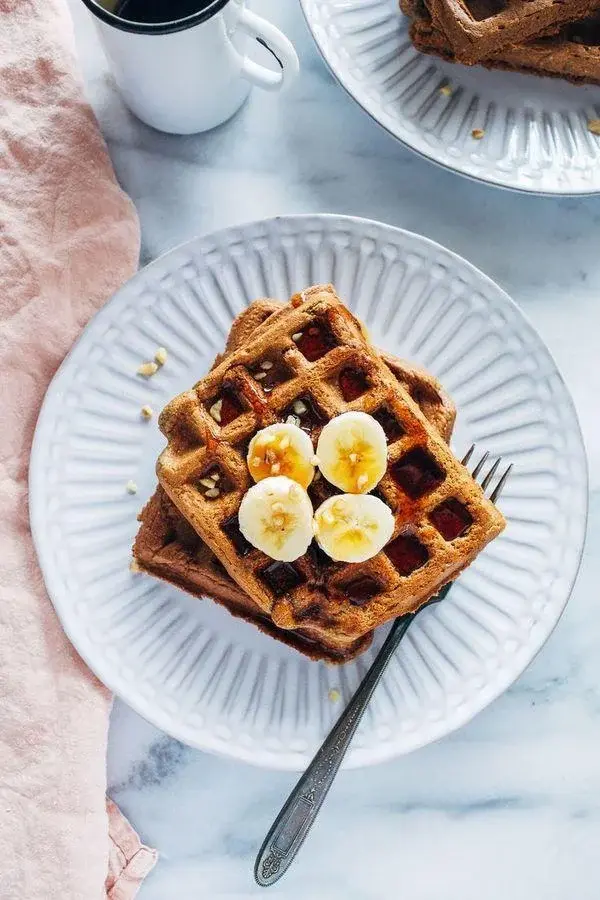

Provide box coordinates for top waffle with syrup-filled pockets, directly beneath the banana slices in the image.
[157,286,504,640]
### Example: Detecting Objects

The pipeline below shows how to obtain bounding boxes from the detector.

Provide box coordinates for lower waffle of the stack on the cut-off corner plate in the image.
[402,0,600,84]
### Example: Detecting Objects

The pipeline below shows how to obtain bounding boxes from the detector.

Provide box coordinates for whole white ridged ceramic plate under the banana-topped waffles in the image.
[31,216,587,768]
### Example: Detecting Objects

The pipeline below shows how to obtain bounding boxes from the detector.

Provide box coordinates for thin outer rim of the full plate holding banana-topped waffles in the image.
[29,213,589,771]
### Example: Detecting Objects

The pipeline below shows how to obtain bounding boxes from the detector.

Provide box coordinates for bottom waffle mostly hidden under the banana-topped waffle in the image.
[133,300,456,663]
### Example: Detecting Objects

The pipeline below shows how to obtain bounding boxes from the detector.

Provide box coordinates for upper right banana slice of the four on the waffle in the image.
[317,412,387,494]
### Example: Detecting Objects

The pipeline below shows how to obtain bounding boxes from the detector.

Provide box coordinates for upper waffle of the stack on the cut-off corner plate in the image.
[427,0,600,63]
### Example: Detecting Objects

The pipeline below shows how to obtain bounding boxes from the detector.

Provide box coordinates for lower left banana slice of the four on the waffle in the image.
[238,475,313,562]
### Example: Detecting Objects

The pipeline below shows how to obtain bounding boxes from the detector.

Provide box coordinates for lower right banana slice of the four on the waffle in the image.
[314,494,394,562]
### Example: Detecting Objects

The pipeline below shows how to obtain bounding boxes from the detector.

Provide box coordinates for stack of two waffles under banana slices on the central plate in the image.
[134,286,504,662]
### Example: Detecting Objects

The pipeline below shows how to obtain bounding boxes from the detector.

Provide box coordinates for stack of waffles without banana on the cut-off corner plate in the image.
[400,0,600,84]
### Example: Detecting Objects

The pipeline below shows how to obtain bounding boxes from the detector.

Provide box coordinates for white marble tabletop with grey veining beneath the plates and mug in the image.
[70,0,600,900]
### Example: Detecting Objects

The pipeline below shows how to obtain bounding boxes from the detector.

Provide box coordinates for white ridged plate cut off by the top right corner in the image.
[301,0,600,194]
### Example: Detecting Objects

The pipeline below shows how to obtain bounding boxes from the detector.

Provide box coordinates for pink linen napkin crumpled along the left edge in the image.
[0,0,155,900]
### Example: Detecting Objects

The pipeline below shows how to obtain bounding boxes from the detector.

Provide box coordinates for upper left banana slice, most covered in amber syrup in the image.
[247,422,315,488]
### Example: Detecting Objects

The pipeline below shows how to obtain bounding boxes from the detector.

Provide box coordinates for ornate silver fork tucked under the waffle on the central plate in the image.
[254,444,512,887]
